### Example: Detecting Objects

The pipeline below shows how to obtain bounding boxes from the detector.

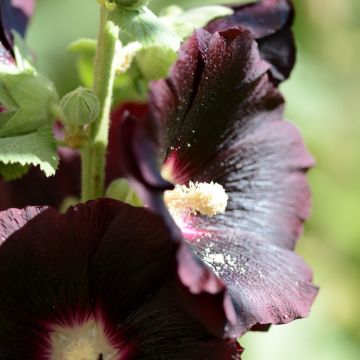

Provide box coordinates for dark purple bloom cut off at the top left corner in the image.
[0,0,35,51]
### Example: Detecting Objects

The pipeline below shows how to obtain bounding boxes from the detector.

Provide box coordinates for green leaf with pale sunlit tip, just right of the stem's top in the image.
[110,7,180,52]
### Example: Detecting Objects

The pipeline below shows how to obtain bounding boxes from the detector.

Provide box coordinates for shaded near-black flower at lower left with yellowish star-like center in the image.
[0,199,240,360]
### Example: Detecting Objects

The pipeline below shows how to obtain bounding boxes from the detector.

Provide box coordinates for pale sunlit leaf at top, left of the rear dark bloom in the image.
[160,5,234,39]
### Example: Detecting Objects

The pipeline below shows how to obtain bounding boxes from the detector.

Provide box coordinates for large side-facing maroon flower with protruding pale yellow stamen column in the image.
[119,28,317,336]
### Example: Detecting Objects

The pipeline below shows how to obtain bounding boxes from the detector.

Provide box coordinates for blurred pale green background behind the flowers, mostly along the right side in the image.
[28,0,360,360]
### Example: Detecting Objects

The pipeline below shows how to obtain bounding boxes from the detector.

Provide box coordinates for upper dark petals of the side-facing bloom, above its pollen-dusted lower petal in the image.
[150,29,313,249]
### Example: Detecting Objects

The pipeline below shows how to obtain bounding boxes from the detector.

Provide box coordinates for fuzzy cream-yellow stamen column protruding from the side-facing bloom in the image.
[164,181,229,217]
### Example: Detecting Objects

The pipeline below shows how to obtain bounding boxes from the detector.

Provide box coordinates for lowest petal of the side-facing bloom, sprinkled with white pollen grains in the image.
[188,229,317,336]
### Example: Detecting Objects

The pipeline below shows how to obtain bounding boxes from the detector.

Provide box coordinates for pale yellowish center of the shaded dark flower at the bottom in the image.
[50,319,120,360]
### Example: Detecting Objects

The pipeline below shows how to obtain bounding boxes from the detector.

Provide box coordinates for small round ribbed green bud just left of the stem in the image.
[60,87,100,126]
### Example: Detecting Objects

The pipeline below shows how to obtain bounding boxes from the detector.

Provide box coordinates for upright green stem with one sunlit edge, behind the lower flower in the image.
[81,5,119,201]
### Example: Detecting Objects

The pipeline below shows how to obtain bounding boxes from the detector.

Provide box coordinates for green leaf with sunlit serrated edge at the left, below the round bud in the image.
[0,126,59,176]
